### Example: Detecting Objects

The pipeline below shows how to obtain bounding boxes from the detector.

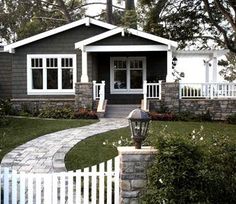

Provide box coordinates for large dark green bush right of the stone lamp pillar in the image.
[143,126,236,204]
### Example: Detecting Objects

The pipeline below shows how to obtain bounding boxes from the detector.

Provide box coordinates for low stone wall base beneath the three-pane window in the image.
[11,98,75,112]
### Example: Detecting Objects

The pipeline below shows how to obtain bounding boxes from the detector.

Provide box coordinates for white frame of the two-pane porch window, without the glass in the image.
[110,56,147,94]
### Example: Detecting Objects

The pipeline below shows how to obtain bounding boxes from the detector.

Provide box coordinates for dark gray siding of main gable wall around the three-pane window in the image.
[12,25,107,98]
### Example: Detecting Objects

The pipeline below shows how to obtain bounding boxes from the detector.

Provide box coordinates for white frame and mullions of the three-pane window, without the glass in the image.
[27,54,77,95]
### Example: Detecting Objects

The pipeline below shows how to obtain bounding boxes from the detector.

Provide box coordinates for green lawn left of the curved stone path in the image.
[0,118,96,161]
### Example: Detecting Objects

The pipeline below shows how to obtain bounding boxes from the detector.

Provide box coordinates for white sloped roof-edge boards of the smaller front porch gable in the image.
[75,27,178,49]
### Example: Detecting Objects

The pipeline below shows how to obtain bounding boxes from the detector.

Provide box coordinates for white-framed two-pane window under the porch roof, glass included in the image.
[110,57,146,94]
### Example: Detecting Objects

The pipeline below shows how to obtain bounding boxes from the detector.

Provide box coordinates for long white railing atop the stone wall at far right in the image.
[179,83,236,99]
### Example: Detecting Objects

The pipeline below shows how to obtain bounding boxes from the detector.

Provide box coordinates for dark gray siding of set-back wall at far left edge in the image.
[0,52,12,98]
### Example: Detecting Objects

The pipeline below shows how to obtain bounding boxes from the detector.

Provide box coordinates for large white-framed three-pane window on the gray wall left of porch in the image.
[27,54,76,95]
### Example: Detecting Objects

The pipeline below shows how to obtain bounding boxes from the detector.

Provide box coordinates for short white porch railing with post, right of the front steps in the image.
[143,80,162,110]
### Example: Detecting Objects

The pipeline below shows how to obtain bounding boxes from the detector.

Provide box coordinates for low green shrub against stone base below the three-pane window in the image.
[38,107,74,119]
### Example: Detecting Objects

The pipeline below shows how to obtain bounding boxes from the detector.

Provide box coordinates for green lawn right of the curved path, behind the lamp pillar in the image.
[65,121,236,170]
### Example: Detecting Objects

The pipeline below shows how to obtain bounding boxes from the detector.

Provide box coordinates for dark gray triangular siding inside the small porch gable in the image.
[90,33,164,45]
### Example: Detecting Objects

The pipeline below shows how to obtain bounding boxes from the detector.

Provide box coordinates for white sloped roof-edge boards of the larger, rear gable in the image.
[4,17,116,52]
